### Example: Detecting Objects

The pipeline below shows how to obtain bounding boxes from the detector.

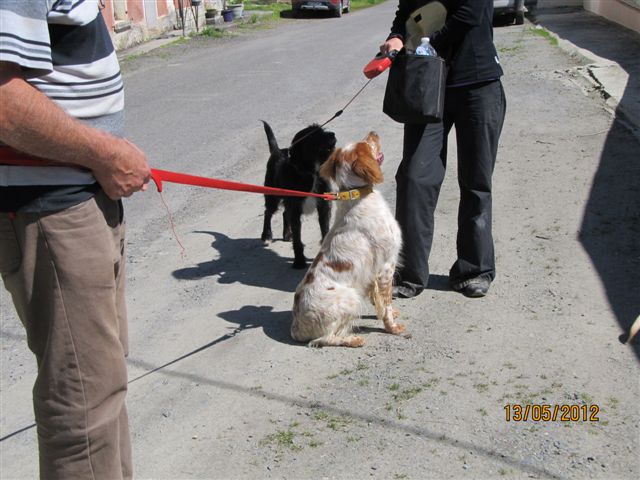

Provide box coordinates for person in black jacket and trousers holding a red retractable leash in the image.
[380,0,506,298]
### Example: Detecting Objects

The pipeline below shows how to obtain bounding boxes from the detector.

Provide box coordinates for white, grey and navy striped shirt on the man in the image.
[0,0,124,212]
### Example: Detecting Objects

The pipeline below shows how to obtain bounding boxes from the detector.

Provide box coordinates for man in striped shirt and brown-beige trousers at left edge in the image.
[0,0,150,479]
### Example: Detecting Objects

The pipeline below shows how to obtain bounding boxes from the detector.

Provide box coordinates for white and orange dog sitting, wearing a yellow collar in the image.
[291,132,405,347]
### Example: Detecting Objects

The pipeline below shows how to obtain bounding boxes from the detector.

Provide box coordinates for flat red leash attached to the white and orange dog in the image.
[0,151,336,200]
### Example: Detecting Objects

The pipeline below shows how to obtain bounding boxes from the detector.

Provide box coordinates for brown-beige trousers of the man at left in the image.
[0,193,132,480]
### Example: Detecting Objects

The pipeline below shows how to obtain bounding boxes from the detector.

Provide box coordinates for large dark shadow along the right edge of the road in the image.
[538,8,640,358]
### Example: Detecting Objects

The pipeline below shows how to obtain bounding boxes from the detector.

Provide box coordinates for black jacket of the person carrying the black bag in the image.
[388,0,503,86]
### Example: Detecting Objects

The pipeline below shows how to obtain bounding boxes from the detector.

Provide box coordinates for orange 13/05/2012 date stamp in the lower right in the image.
[504,403,600,422]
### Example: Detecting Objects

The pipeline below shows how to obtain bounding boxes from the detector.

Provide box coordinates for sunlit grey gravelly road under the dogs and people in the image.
[0,2,640,479]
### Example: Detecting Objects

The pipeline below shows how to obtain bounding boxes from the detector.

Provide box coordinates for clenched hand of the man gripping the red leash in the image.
[90,137,151,200]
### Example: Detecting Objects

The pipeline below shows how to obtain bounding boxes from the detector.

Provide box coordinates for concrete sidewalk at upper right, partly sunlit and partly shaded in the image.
[534,9,640,139]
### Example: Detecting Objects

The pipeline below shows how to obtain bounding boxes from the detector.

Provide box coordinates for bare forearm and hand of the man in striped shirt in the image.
[0,62,150,200]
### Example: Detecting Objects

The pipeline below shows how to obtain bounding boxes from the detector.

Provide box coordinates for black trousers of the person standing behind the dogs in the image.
[396,80,506,292]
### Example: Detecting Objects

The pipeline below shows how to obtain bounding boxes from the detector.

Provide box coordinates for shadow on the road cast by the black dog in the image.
[173,231,305,292]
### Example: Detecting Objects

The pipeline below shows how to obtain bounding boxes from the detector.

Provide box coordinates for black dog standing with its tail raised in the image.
[262,120,336,268]
